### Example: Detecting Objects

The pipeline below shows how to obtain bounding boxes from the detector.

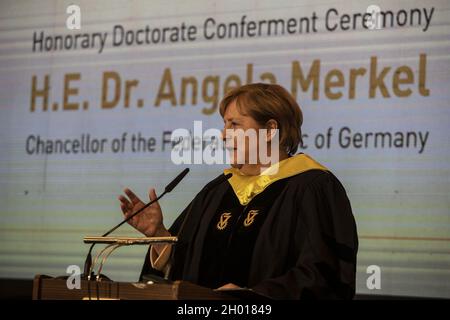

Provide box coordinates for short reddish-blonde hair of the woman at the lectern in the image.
[219,83,303,155]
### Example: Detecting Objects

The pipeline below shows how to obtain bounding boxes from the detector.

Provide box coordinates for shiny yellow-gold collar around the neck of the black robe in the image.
[224,153,328,206]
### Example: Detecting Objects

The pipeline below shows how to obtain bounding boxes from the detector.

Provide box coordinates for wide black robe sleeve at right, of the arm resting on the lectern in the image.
[253,172,358,299]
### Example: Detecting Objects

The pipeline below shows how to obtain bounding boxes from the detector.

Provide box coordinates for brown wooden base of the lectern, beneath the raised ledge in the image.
[33,275,236,300]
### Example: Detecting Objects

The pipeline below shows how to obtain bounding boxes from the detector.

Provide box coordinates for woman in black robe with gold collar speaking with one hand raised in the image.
[119,83,358,299]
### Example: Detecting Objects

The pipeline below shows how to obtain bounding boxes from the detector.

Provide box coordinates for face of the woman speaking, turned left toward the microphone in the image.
[222,101,263,168]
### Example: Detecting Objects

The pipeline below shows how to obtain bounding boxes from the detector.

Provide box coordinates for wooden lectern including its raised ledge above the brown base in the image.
[33,235,265,300]
